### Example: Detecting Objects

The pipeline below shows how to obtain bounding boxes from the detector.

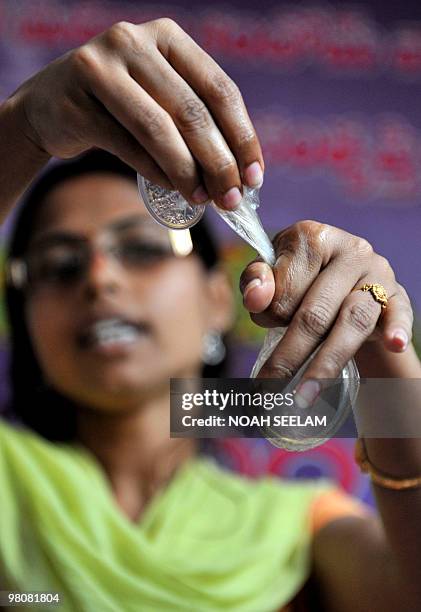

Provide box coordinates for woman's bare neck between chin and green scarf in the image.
[78,388,197,520]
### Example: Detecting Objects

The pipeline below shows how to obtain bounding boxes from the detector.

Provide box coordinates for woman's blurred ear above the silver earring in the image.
[206,267,234,334]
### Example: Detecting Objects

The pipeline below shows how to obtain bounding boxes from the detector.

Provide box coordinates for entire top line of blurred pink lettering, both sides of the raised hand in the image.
[4,0,421,77]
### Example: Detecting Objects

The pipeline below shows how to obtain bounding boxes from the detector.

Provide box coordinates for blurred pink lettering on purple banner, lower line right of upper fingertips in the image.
[256,113,421,205]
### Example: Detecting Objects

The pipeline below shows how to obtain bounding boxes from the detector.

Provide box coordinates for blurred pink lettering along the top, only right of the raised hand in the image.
[195,7,421,76]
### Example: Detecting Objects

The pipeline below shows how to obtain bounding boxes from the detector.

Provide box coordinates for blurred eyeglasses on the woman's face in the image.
[6,228,173,290]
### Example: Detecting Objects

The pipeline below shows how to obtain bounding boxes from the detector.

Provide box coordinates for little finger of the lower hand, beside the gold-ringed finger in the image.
[379,285,414,353]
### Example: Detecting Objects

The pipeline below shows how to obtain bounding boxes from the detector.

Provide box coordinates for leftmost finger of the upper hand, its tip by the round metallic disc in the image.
[86,65,201,200]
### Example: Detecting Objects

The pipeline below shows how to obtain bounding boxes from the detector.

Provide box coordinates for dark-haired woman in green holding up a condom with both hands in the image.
[0,16,421,612]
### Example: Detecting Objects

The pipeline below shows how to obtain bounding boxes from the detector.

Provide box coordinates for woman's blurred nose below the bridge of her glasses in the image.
[83,249,124,299]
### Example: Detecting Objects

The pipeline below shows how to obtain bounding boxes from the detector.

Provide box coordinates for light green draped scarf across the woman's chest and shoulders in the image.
[0,422,327,612]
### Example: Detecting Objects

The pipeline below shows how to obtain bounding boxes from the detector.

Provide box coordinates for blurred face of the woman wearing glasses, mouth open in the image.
[26,174,229,411]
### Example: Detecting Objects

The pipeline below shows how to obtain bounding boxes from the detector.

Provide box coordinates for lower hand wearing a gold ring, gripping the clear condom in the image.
[240,221,413,403]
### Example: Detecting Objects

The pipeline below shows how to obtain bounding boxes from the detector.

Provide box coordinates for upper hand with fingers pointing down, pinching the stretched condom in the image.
[12,19,263,209]
